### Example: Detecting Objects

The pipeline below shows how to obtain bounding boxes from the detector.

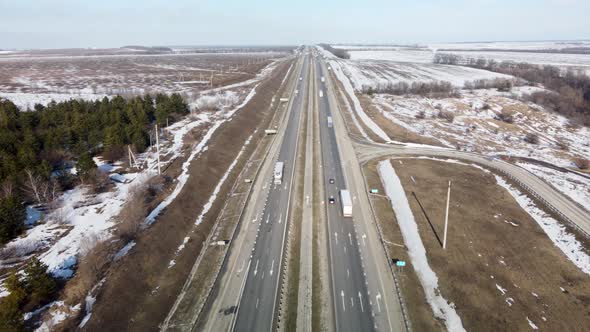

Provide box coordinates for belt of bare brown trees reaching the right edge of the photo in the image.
[434,53,590,126]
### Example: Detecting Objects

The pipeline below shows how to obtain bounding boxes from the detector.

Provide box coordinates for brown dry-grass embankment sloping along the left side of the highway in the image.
[81,58,296,331]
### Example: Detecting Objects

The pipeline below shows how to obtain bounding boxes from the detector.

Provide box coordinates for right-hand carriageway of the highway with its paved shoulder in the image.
[315,53,407,331]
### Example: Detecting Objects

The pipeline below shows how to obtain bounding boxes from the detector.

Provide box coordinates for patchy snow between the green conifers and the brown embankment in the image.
[0,59,274,278]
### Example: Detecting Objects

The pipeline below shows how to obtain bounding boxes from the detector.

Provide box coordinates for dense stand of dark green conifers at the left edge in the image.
[0,94,189,245]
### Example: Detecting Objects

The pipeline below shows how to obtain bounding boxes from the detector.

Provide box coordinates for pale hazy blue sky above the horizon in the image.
[0,0,590,49]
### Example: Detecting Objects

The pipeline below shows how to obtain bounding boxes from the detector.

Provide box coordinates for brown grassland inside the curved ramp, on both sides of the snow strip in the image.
[365,159,590,331]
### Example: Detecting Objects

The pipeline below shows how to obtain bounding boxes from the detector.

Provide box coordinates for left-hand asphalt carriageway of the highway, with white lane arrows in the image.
[234,50,309,331]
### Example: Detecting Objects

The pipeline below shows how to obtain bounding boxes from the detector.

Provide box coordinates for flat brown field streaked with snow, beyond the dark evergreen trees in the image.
[0,51,287,110]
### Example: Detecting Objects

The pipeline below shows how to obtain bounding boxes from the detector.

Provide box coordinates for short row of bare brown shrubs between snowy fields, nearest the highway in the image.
[361,81,459,98]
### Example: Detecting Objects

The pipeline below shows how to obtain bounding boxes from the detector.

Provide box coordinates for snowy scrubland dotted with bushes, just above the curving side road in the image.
[373,87,590,209]
